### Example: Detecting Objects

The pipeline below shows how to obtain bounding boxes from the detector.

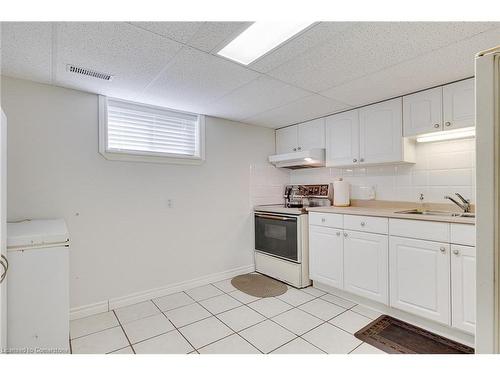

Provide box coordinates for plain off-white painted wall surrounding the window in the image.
[2,78,274,307]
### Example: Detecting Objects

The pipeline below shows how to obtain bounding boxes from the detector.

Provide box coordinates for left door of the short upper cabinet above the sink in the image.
[403,87,443,137]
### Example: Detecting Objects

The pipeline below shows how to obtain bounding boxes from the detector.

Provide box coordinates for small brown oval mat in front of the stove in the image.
[231,273,288,298]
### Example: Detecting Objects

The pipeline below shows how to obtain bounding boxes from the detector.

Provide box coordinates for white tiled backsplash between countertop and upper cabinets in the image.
[290,139,475,203]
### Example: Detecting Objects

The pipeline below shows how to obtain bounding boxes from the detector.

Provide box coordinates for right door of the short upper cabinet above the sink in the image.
[443,78,476,130]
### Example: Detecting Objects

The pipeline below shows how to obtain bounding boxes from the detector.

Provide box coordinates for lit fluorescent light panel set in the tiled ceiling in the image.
[218,21,313,65]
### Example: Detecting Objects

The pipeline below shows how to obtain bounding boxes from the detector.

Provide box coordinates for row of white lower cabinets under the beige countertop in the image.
[309,213,476,334]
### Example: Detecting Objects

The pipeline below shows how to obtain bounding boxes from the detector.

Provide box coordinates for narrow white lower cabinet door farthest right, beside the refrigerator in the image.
[451,245,476,333]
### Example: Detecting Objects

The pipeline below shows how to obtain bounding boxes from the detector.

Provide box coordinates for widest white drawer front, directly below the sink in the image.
[389,219,450,242]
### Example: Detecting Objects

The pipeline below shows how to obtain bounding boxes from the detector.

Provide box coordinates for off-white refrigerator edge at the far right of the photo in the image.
[475,47,500,353]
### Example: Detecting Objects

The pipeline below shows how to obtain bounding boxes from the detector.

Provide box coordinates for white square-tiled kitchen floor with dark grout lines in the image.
[71,280,383,354]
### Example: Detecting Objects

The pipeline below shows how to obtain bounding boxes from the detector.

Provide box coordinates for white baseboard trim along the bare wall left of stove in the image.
[70,264,255,320]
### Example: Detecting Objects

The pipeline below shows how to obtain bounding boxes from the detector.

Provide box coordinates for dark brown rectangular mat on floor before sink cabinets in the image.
[354,315,474,354]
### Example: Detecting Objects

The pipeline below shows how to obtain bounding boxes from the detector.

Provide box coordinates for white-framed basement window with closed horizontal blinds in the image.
[99,96,205,164]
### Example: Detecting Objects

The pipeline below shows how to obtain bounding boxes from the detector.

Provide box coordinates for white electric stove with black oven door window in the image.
[254,184,333,288]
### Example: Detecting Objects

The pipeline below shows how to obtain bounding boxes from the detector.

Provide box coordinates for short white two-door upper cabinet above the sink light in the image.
[403,78,475,137]
